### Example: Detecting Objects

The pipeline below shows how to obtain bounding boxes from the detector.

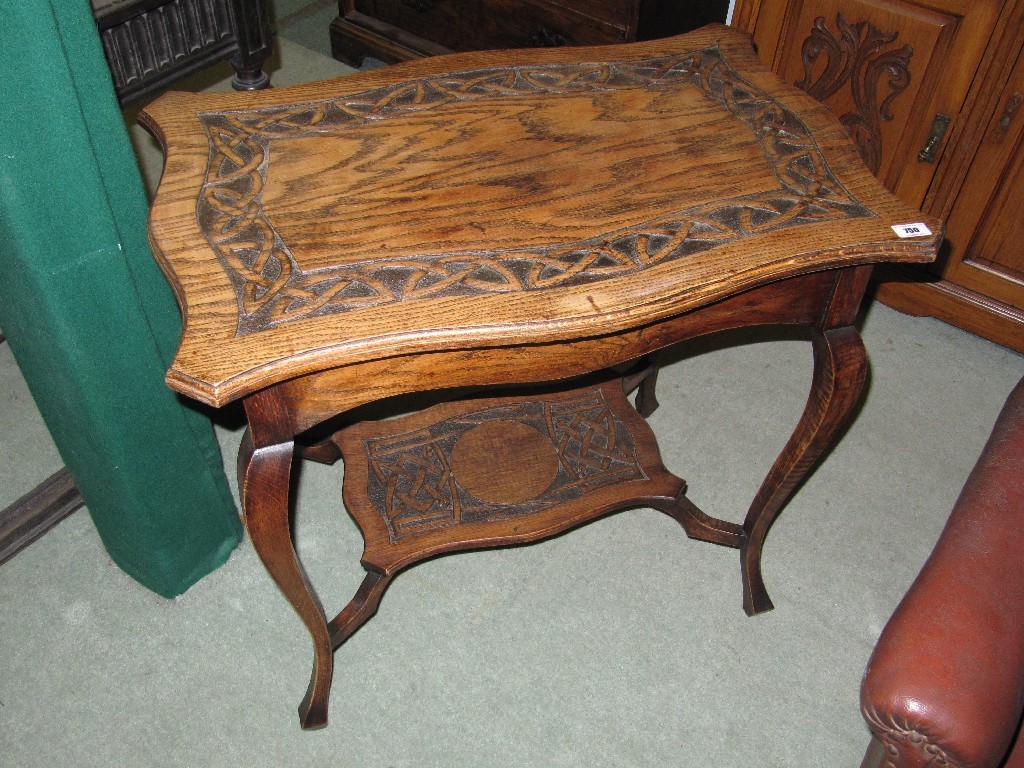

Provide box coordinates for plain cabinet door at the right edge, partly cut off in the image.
[943,55,1024,309]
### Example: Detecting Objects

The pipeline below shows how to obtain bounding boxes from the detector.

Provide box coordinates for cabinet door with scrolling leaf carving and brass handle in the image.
[733,0,1002,205]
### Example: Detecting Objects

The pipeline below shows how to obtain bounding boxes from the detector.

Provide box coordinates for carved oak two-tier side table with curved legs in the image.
[141,27,941,728]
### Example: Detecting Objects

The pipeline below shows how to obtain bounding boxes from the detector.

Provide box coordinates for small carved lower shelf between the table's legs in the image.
[332,379,742,575]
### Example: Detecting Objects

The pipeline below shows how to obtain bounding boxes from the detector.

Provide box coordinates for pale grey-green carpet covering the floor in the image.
[0,22,1024,768]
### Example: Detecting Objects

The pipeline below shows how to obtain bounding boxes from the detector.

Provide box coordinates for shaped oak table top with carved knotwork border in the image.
[141,26,941,406]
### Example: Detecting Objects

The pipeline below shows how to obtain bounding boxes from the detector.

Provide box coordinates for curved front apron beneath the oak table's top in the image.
[246,266,870,446]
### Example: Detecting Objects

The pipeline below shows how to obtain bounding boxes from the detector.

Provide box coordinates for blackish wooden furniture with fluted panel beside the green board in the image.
[92,0,273,106]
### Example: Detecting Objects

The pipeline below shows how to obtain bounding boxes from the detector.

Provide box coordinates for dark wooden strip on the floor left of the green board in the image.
[0,468,84,564]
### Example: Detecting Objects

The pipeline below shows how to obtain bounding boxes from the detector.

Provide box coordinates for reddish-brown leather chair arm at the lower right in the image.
[860,380,1024,768]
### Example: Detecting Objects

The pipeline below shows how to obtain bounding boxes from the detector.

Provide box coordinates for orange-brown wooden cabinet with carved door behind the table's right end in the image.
[733,0,1024,351]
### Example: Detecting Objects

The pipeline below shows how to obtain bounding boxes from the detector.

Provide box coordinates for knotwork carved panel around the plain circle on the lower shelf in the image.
[364,390,647,543]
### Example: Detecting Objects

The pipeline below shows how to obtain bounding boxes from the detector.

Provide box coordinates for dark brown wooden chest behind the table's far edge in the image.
[331,0,728,67]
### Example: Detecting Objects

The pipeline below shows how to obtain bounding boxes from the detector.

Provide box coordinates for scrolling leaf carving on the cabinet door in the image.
[796,13,913,173]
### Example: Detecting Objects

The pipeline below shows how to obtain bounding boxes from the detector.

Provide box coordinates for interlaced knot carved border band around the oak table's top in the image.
[197,48,872,335]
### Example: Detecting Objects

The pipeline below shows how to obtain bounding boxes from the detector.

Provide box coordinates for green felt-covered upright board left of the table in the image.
[0,0,242,597]
